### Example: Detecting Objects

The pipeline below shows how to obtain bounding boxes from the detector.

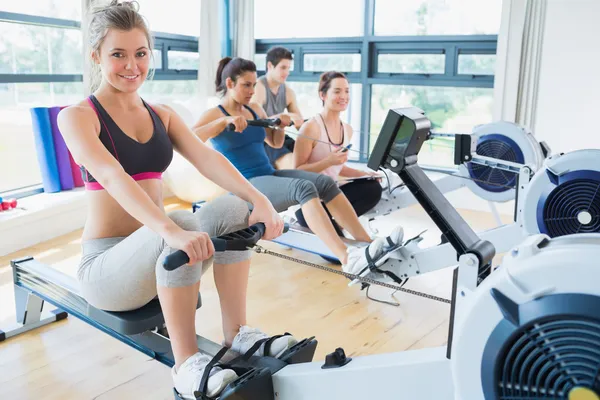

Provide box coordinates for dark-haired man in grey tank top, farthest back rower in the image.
[252,47,303,169]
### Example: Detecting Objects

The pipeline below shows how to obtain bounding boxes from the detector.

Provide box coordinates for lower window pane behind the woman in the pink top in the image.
[287,81,362,160]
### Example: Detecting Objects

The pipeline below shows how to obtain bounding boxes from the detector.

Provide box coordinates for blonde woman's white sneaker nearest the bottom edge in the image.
[171,352,238,400]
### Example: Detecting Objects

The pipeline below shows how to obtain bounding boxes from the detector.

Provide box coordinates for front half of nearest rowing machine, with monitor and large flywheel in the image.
[260,104,600,400]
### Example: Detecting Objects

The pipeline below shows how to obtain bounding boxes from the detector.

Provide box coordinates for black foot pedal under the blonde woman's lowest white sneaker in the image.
[173,368,275,400]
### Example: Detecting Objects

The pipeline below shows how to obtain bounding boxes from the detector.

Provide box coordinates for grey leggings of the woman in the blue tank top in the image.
[250,169,342,212]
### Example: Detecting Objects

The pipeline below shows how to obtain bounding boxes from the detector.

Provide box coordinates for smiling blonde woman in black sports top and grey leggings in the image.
[58,0,296,398]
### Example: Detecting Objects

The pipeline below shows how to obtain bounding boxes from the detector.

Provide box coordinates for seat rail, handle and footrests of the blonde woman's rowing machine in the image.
[0,223,317,399]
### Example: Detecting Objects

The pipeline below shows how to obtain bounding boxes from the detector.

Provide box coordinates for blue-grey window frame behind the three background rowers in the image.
[255,0,498,162]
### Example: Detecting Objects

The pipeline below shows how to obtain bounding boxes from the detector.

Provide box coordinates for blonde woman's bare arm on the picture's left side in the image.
[58,106,180,237]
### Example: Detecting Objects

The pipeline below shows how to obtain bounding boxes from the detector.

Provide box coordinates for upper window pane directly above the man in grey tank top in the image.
[254,0,364,39]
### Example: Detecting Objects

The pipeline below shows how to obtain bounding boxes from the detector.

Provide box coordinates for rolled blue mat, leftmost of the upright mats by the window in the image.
[30,107,60,193]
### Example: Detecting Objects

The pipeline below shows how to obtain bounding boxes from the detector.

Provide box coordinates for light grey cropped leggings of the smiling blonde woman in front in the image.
[77,195,251,311]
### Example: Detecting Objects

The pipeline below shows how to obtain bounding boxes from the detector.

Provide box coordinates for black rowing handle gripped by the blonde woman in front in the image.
[163,222,289,271]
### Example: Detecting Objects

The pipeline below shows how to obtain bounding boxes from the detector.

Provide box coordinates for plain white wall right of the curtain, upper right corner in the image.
[533,0,600,153]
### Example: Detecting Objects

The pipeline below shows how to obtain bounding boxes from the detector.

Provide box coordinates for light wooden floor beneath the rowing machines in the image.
[0,201,510,400]
